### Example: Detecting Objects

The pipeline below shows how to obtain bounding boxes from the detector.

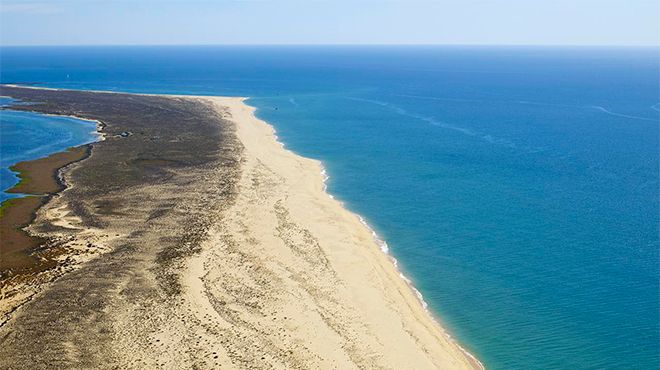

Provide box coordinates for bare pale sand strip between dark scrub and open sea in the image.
[178,97,480,369]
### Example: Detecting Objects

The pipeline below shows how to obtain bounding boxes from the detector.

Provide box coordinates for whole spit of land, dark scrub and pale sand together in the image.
[0,88,481,369]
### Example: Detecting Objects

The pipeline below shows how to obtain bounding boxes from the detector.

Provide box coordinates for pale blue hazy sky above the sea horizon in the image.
[0,0,660,45]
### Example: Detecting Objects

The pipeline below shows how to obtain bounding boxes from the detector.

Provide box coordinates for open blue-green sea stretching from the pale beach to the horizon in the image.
[1,47,660,369]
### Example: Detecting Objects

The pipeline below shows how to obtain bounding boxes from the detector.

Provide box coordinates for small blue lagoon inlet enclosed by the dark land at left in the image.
[0,97,97,202]
